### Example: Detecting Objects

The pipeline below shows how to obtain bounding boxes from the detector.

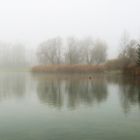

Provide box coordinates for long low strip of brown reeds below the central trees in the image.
[32,65,105,73]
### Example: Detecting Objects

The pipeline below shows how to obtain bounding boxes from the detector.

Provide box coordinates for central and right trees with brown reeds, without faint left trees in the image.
[32,33,140,76]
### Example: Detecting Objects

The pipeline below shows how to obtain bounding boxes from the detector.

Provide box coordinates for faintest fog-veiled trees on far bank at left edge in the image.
[0,42,27,68]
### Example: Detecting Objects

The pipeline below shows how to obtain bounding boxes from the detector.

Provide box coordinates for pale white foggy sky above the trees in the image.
[0,0,140,57]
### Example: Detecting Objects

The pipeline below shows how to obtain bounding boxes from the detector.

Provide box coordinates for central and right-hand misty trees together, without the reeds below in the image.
[37,32,140,69]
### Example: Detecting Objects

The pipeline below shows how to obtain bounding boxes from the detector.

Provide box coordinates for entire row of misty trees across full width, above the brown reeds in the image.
[0,33,140,69]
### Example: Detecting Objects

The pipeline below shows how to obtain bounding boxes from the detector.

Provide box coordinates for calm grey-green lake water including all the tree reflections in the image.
[0,73,140,140]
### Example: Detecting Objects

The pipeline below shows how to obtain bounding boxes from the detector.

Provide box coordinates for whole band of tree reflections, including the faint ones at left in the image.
[0,72,140,113]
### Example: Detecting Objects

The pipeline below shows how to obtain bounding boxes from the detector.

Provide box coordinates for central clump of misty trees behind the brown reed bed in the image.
[37,37,107,64]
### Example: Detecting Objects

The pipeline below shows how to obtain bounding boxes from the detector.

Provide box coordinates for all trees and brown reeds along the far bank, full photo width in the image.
[0,32,140,76]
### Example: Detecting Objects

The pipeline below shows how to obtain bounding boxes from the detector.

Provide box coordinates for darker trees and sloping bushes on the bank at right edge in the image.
[106,32,140,69]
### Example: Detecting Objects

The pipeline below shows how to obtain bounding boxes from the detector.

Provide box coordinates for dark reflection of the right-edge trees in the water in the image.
[107,77,140,113]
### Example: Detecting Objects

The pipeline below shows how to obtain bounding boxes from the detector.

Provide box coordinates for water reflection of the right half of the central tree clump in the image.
[66,80,107,108]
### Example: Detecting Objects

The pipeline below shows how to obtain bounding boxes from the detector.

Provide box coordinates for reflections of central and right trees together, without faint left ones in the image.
[37,74,140,113]
